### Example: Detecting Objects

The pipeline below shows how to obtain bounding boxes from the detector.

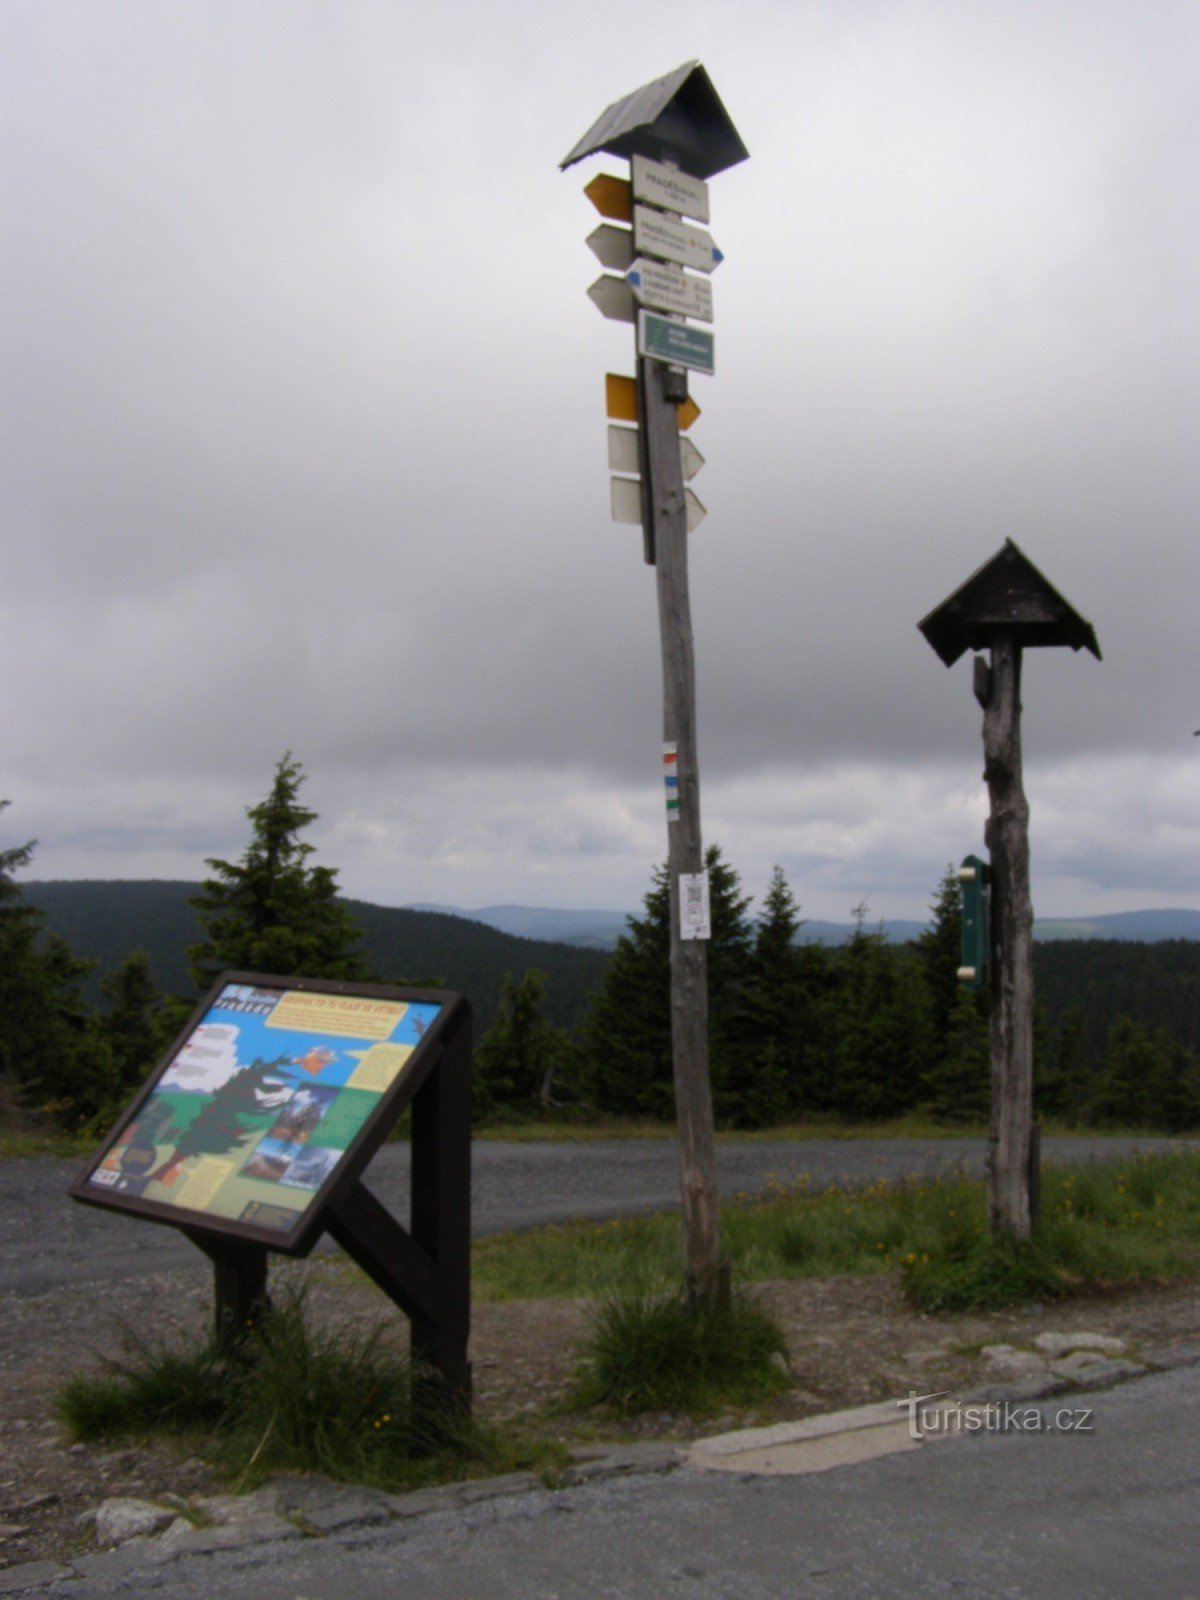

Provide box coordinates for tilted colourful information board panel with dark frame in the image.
[70,973,459,1253]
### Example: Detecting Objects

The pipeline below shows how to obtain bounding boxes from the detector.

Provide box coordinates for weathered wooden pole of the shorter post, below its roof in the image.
[978,629,1034,1238]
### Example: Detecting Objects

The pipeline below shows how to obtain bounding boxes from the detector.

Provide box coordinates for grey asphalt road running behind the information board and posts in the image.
[0,1138,1200,1292]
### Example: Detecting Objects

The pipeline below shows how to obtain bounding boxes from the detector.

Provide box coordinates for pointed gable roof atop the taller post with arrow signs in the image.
[560,61,750,178]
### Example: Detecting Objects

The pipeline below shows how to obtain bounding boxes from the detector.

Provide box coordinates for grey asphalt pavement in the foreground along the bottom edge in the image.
[25,1366,1200,1600]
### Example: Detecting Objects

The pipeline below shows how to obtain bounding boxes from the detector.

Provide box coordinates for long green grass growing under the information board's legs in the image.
[56,1291,562,1490]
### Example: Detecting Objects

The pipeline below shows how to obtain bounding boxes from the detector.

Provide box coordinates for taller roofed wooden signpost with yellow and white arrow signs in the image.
[562,61,749,1304]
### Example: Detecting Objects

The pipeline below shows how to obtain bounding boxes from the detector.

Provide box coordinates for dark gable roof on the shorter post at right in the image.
[917,539,1099,667]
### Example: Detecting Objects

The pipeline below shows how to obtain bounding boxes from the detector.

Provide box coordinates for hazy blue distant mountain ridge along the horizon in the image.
[408,904,1200,950]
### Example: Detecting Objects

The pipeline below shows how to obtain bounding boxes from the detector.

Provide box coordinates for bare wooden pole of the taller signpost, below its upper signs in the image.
[638,347,728,1302]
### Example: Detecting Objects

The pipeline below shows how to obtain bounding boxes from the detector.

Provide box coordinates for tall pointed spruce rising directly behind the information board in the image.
[189,752,370,987]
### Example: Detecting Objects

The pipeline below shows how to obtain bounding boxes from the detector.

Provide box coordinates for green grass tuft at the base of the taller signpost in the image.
[571,1290,790,1416]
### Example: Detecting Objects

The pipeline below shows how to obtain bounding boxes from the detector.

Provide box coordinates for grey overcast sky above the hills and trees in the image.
[0,0,1200,920]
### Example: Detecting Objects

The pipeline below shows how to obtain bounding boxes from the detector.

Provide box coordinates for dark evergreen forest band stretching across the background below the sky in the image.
[0,757,1200,1131]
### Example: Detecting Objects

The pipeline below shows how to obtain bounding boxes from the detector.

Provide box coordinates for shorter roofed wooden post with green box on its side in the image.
[917,539,1099,1238]
